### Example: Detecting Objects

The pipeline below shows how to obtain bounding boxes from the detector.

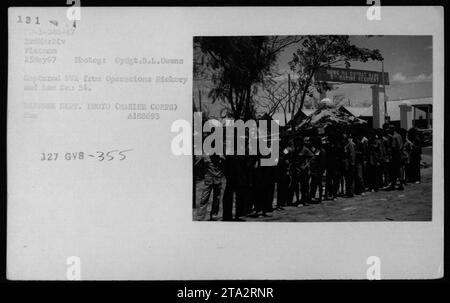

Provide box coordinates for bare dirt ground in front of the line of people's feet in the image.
[193,148,432,222]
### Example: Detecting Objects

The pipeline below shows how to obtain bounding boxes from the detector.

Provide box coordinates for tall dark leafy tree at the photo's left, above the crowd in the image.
[194,36,302,119]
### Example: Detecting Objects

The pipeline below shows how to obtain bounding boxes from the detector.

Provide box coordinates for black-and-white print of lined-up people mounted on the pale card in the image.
[193,35,433,222]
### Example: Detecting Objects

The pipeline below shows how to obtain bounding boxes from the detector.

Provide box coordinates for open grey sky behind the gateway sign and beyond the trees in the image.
[278,36,433,106]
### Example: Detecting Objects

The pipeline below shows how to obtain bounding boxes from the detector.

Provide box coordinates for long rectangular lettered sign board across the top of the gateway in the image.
[316,67,389,85]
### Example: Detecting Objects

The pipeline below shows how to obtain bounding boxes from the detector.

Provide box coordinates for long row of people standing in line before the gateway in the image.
[195,124,422,221]
